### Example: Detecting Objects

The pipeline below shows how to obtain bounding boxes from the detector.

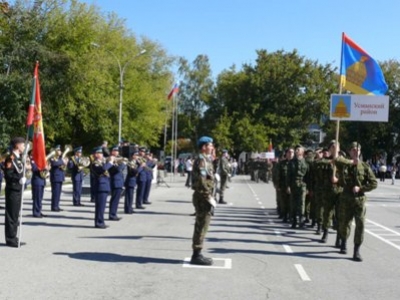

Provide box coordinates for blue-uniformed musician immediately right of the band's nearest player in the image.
[108,146,126,221]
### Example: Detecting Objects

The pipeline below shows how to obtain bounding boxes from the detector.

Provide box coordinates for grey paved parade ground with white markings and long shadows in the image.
[0,176,400,300]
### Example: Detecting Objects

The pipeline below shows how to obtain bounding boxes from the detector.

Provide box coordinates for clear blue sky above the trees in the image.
[81,0,400,76]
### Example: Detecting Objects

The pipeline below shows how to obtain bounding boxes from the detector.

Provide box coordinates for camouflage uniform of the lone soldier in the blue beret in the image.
[192,154,214,250]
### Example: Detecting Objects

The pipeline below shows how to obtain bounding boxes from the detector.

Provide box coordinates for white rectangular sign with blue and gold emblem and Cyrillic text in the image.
[330,94,389,122]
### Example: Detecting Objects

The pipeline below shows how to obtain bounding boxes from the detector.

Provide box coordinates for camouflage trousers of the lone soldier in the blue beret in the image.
[192,191,211,250]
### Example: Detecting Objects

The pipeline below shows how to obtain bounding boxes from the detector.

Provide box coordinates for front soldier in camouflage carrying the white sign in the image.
[335,142,378,261]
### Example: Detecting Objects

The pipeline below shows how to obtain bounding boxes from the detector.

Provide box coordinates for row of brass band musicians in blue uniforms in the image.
[27,145,155,228]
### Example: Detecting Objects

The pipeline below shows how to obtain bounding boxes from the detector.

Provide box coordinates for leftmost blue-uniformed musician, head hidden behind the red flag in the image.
[31,160,46,218]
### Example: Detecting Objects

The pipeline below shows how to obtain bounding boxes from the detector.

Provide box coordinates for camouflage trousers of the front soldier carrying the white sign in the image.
[339,193,367,245]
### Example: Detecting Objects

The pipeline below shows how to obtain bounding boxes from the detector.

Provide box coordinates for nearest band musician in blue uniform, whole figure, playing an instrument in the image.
[91,147,113,229]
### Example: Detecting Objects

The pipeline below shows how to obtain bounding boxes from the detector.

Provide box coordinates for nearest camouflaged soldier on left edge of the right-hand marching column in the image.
[288,145,309,228]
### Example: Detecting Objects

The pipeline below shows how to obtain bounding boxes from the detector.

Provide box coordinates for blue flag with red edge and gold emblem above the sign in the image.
[340,33,388,95]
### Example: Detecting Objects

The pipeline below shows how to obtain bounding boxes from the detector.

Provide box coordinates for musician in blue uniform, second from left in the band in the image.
[50,145,65,212]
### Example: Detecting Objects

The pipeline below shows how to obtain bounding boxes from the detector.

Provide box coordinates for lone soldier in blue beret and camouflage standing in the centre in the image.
[190,136,216,266]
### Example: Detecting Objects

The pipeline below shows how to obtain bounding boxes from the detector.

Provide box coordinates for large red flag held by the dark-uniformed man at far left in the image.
[27,62,47,170]
